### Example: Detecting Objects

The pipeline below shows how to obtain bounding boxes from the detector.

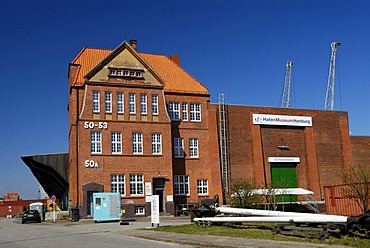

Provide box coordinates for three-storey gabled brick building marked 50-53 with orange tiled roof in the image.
[68,41,221,216]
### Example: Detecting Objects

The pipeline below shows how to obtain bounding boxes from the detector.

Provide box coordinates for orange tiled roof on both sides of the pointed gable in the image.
[72,48,209,94]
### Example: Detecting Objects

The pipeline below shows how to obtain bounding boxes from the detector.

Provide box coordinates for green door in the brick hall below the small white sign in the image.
[271,163,298,202]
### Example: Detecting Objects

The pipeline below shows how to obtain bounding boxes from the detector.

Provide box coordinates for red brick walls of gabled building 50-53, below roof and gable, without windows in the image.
[69,70,217,217]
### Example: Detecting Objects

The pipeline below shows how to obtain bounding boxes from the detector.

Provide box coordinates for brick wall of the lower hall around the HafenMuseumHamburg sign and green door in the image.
[221,105,352,200]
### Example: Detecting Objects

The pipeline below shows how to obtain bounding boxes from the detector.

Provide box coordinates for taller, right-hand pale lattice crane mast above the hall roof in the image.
[324,42,340,110]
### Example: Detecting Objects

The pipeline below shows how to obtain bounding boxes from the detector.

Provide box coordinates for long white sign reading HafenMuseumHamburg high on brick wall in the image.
[253,114,312,127]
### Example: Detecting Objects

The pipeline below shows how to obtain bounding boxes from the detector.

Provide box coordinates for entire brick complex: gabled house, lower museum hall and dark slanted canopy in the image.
[22,40,370,217]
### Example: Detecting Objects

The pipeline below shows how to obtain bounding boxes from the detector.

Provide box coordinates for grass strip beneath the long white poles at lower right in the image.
[153,224,370,247]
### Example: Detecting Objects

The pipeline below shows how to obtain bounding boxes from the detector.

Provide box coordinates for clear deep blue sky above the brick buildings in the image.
[0,0,370,199]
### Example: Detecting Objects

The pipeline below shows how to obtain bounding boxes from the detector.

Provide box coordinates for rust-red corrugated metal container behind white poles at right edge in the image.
[324,185,363,216]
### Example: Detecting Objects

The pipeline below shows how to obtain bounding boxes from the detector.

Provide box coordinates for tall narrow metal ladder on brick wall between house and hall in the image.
[218,93,230,194]
